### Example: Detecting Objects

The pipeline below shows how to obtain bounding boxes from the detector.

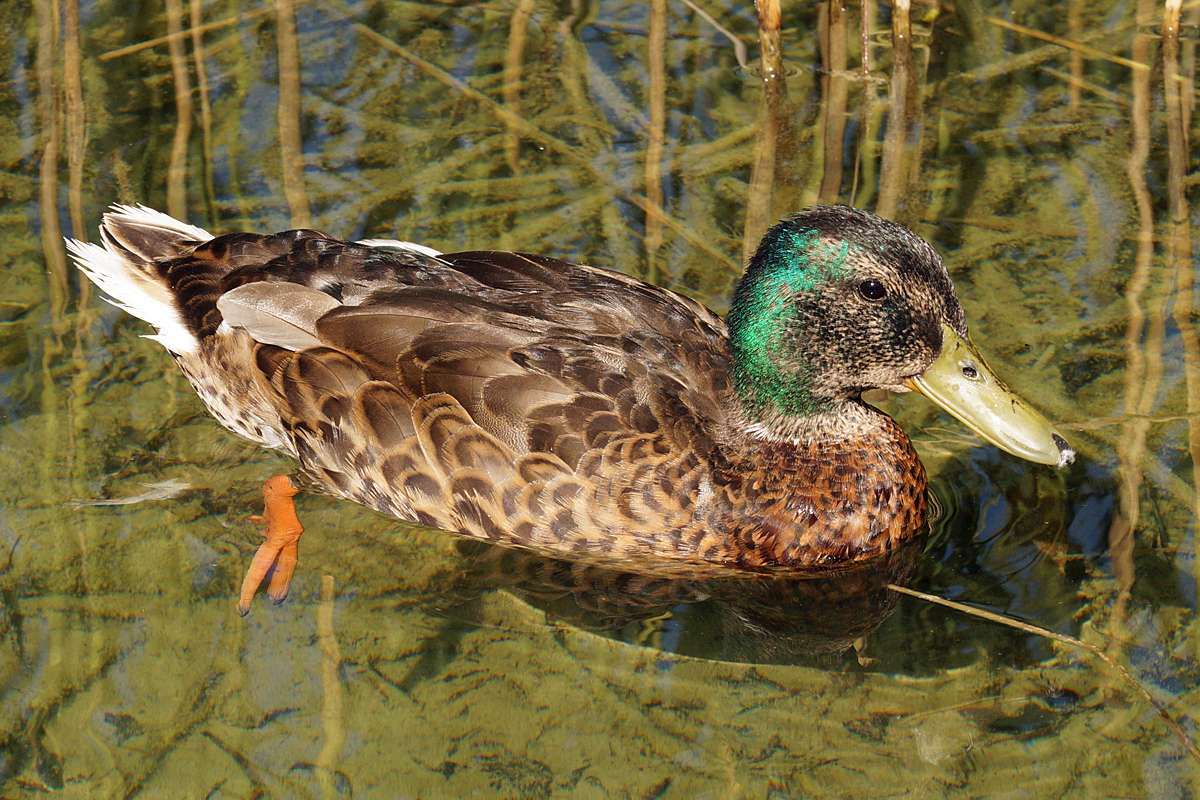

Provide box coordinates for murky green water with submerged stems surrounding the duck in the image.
[0,0,1200,798]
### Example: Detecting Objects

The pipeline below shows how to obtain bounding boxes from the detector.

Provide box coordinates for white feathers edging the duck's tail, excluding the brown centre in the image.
[66,205,212,354]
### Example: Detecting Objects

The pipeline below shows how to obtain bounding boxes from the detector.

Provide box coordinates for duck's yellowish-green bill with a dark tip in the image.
[907,325,1075,467]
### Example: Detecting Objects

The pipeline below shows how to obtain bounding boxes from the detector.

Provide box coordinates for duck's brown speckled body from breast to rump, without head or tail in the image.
[110,221,925,572]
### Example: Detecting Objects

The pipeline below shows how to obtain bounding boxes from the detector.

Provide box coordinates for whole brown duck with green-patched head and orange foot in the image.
[67,205,1074,614]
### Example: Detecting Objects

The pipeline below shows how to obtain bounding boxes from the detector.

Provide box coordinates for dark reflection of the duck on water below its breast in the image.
[439,537,922,666]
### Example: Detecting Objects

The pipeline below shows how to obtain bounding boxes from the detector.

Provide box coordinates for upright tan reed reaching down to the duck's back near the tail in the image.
[275,0,312,228]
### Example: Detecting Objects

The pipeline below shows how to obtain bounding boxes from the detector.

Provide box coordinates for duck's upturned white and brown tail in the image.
[67,205,212,355]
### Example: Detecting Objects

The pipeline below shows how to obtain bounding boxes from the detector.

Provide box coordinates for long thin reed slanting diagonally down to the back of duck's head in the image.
[353,23,738,271]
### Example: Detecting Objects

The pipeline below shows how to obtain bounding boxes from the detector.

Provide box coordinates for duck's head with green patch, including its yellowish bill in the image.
[727,206,1074,467]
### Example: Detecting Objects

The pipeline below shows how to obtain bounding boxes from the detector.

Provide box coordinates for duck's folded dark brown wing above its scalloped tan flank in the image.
[276,252,727,469]
